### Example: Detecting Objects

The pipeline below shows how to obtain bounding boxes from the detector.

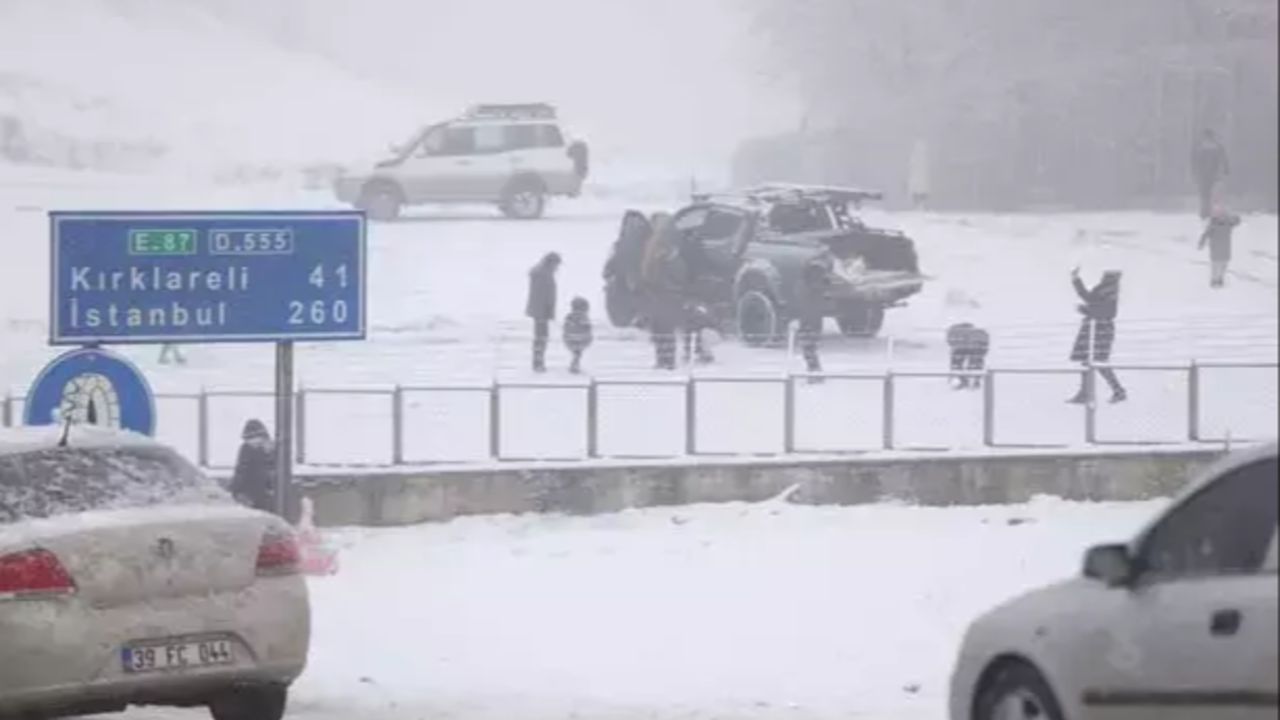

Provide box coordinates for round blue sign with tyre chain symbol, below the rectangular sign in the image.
[24,348,156,436]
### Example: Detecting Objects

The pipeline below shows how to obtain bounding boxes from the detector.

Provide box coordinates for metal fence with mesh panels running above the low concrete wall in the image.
[0,361,1277,469]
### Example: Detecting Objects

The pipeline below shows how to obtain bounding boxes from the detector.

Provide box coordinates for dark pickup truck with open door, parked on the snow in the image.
[604,184,924,345]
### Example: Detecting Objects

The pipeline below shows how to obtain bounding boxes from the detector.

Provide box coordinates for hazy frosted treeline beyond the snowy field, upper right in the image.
[733,0,1280,210]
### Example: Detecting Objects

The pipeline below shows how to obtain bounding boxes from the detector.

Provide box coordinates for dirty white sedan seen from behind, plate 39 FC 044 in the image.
[0,428,311,720]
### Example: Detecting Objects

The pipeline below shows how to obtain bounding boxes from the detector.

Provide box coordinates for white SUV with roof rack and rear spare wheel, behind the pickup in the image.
[334,104,588,220]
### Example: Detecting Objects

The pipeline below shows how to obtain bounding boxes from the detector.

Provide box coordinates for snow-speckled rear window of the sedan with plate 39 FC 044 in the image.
[0,447,232,524]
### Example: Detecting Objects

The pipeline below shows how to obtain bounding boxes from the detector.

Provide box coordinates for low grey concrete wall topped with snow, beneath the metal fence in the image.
[298,448,1224,527]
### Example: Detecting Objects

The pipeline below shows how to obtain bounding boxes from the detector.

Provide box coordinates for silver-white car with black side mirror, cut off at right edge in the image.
[951,443,1280,720]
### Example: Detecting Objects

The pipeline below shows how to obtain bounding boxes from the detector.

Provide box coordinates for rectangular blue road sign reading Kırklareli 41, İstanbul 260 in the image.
[49,211,366,345]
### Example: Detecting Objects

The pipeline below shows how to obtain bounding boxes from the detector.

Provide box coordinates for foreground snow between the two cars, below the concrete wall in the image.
[82,498,1160,720]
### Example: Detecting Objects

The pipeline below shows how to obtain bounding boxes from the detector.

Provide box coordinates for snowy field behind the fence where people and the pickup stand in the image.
[0,170,1277,465]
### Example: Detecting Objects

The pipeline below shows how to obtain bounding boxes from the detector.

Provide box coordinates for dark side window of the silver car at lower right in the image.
[1139,457,1280,579]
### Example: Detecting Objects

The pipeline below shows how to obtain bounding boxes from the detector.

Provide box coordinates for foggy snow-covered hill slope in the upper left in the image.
[0,0,419,178]
